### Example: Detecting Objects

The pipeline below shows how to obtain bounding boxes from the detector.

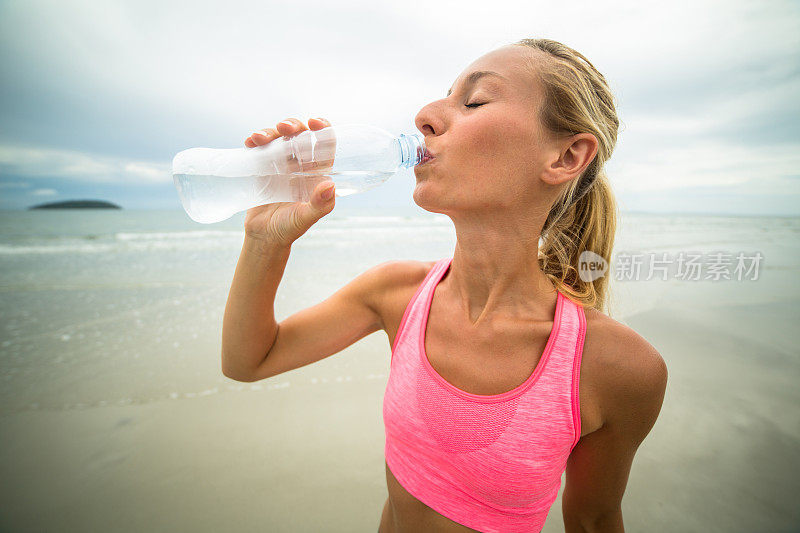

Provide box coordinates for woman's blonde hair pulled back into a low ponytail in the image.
[512,39,619,312]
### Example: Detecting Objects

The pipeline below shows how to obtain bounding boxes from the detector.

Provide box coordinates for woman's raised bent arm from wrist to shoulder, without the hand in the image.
[222,234,398,381]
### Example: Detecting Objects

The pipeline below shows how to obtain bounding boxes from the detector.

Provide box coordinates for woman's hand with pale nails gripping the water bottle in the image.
[244,118,336,246]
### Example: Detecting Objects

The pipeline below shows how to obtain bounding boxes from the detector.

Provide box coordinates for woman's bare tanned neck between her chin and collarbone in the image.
[447,213,556,326]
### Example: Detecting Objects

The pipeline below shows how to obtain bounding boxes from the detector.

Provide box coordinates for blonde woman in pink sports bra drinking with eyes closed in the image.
[222,39,667,533]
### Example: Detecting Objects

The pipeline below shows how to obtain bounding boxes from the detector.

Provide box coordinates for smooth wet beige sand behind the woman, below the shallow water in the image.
[0,280,800,532]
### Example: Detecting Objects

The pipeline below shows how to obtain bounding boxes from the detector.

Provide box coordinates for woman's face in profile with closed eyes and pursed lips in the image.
[414,45,549,214]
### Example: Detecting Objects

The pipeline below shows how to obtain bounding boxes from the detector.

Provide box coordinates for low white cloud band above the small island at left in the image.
[0,145,172,184]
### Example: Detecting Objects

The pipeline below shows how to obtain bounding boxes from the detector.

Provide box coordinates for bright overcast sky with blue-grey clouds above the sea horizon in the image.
[0,0,800,215]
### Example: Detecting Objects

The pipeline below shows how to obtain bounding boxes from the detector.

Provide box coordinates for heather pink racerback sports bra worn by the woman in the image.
[383,258,586,533]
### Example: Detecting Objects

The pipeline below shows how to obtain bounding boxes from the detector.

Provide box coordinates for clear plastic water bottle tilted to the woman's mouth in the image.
[172,124,425,224]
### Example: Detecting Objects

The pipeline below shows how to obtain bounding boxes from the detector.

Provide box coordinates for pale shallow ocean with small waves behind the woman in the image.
[0,207,800,414]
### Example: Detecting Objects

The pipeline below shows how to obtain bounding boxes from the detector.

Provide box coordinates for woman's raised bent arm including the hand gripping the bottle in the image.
[222,115,380,381]
